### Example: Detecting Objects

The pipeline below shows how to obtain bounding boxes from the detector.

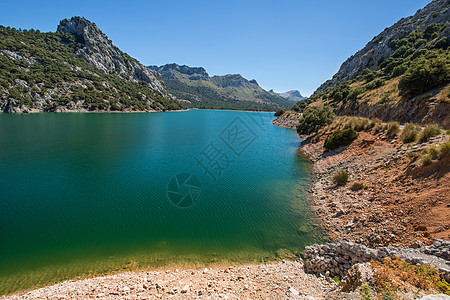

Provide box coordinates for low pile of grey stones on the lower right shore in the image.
[304,240,450,281]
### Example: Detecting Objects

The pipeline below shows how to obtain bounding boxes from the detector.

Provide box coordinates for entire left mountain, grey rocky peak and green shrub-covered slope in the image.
[0,17,182,112]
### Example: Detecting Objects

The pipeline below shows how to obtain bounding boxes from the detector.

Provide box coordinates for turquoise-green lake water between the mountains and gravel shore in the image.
[0,110,319,293]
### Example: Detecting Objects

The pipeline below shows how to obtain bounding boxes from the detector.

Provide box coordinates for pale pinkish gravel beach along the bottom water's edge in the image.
[0,261,337,299]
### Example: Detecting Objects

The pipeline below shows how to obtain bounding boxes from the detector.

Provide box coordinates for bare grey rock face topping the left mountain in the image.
[57,17,167,96]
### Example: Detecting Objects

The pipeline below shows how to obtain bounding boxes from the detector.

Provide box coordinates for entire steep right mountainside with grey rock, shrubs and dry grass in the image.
[293,0,450,128]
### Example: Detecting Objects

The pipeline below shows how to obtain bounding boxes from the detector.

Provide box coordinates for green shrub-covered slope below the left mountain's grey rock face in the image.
[0,26,182,111]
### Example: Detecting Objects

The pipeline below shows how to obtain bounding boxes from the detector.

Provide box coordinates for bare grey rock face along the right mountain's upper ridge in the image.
[315,0,450,94]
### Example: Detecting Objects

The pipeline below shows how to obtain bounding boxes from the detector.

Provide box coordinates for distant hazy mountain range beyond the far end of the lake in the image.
[149,64,292,110]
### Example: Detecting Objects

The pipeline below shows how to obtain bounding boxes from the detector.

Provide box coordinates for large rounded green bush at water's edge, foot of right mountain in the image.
[297,106,335,134]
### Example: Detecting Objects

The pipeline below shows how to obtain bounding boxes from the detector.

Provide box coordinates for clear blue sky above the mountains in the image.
[0,0,430,96]
